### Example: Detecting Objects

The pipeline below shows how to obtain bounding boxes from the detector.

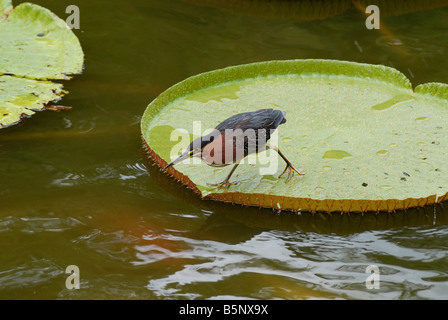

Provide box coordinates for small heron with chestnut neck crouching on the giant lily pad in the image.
[163,109,304,192]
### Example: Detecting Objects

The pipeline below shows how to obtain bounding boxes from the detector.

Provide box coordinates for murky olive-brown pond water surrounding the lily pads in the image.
[0,0,448,299]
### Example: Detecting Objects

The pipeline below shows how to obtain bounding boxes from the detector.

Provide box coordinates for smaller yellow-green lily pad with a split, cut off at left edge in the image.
[0,0,84,128]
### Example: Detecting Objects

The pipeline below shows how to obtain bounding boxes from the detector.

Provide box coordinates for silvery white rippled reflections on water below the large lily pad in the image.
[136,228,448,299]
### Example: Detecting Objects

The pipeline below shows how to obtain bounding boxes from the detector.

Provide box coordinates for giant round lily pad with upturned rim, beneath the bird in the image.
[141,60,448,212]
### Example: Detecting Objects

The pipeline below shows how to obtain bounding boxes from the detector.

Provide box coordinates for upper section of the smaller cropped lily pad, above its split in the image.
[0,3,83,79]
